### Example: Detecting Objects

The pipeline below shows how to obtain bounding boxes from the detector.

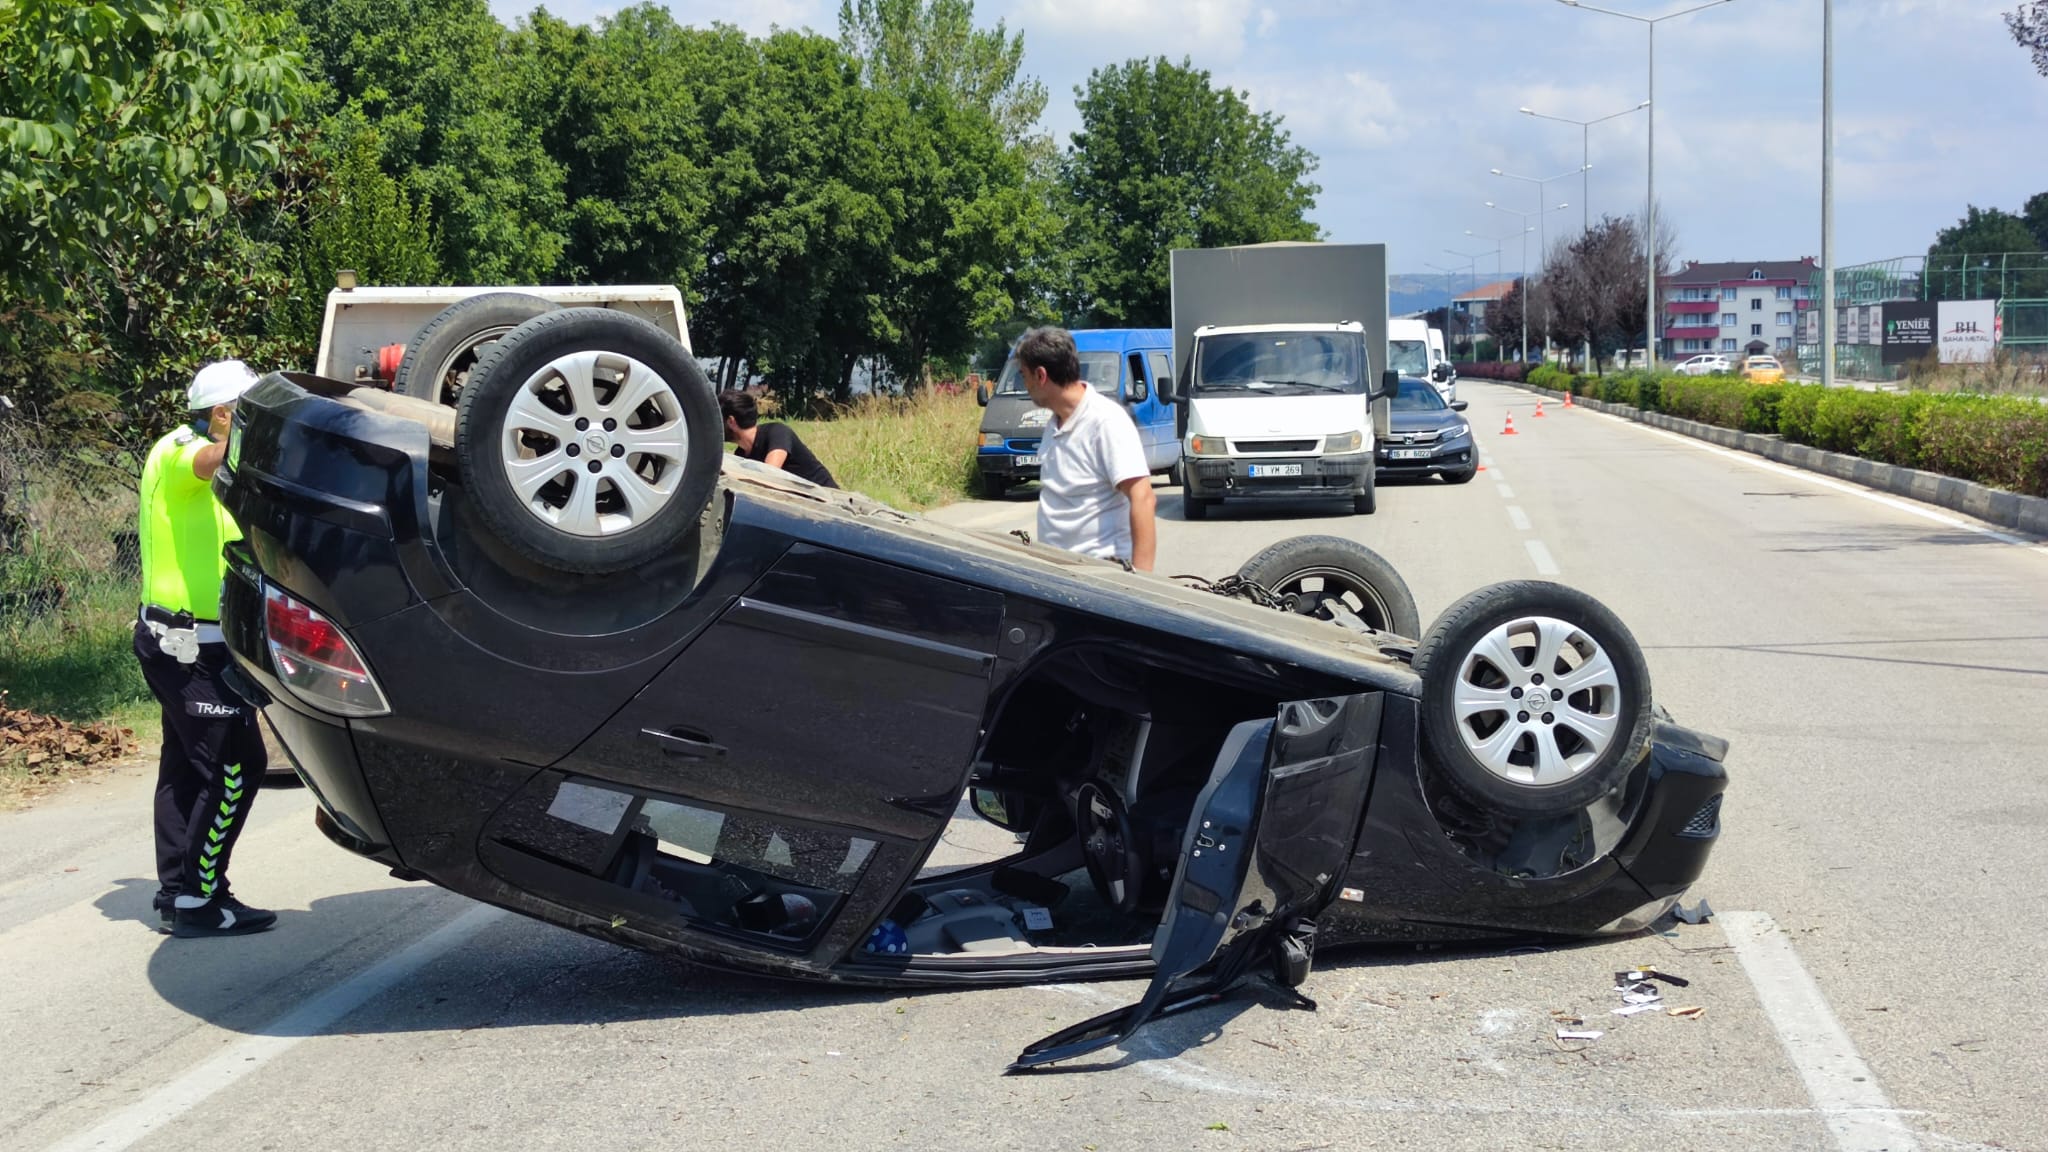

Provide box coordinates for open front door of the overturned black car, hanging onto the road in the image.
[1010,693,1380,1072]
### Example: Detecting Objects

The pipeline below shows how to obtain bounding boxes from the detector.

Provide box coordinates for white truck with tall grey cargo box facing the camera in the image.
[1171,242,1397,521]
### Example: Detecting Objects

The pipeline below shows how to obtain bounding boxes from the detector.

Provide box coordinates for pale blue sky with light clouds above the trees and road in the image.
[492,0,2048,279]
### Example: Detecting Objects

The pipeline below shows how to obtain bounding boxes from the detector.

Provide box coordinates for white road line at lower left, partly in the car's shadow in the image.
[51,904,504,1152]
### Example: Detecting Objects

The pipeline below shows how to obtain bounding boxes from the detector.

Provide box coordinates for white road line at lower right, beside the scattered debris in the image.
[1720,912,1919,1152]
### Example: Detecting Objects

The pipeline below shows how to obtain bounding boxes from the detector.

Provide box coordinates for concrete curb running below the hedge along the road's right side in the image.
[1489,379,2048,537]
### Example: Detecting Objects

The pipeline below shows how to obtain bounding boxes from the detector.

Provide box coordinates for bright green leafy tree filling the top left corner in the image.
[0,0,307,303]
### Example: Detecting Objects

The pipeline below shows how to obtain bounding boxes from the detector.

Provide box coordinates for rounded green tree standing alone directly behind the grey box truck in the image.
[1061,57,1321,326]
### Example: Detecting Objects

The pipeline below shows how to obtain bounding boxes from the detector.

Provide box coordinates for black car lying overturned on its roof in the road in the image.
[215,297,1726,1066]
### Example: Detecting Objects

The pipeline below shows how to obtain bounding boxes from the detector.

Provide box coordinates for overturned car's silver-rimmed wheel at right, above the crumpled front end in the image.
[1415,580,1655,816]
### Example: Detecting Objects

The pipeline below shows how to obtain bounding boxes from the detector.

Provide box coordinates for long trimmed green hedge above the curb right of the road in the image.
[1528,365,2048,496]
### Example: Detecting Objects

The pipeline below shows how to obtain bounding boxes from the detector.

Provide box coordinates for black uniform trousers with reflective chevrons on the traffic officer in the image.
[135,623,268,908]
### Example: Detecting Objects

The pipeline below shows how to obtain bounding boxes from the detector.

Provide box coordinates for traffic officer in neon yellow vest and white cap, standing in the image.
[135,361,276,937]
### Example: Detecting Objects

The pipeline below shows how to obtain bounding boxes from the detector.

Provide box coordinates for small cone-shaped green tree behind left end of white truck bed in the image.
[279,125,440,351]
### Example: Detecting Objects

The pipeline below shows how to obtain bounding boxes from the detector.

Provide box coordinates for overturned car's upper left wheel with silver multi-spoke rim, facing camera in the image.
[455,307,721,574]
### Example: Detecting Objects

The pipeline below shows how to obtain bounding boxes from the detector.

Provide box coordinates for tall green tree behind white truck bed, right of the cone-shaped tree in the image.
[262,0,565,283]
